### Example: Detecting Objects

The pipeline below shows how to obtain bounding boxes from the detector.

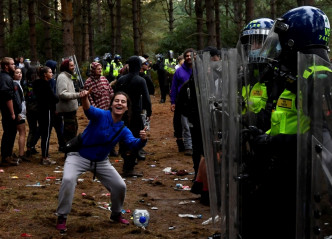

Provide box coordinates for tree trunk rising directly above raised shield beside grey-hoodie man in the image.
[73,0,83,64]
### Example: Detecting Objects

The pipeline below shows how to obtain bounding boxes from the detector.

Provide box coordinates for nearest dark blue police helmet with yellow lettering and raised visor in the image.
[261,6,330,59]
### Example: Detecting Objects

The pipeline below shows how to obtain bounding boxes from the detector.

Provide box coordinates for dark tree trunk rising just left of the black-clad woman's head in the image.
[28,0,38,64]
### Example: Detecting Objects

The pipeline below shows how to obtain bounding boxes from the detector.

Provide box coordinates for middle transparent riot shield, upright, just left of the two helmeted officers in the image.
[222,49,244,238]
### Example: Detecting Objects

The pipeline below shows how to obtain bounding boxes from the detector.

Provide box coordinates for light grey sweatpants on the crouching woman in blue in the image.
[56,152,126,217]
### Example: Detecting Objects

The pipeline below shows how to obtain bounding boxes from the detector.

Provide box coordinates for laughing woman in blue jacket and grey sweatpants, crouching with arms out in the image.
[56,90,147,231]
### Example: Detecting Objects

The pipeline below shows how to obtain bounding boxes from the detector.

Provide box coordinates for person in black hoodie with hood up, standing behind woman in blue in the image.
[114,56,152,177]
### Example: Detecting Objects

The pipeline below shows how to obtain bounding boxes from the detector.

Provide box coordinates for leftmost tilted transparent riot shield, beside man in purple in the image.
[193,52,222,230]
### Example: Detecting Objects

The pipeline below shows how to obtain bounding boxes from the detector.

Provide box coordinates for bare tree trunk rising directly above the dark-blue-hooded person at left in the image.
[41,0,52,59]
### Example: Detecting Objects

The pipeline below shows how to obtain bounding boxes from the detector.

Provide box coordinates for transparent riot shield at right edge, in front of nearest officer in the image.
[296,53,332,239]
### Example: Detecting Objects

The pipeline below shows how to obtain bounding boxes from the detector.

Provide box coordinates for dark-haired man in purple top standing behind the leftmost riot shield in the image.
[171,48,195,156]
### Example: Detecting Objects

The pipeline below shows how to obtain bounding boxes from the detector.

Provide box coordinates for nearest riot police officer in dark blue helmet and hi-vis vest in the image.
[248,6,330,238]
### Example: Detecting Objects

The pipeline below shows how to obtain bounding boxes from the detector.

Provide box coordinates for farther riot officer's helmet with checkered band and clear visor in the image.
[240,18,274,62]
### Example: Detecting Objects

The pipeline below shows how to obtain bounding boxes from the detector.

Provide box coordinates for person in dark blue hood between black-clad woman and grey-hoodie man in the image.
[45,60,65,152]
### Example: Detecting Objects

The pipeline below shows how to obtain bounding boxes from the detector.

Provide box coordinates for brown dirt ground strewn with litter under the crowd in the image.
[0,92,220,239]
